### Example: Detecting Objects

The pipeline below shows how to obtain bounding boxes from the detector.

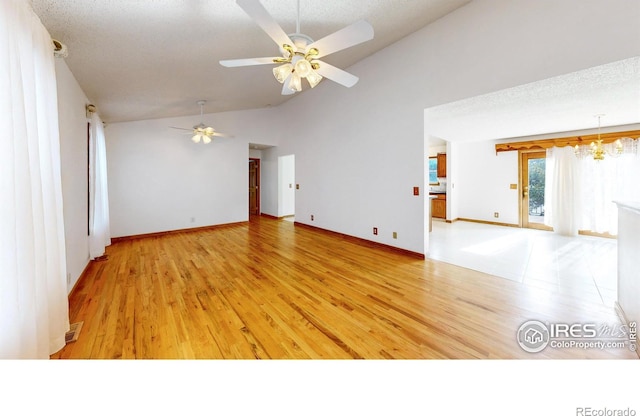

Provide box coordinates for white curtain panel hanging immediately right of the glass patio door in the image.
[544,146,581,236]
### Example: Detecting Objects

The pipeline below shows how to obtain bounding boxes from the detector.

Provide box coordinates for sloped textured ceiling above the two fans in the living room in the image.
[31,0,470,122]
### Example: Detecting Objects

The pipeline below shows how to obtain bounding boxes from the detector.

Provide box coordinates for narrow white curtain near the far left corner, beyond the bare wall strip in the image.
[89,113,111,259]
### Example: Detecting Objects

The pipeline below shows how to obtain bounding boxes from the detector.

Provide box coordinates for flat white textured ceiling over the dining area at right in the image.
[425,57,640,143]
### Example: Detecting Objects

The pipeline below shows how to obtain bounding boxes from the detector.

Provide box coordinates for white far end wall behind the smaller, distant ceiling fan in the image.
[105,116,249,237]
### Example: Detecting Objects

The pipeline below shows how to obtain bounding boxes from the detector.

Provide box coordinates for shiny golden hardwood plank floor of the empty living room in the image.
[52,217,637,359]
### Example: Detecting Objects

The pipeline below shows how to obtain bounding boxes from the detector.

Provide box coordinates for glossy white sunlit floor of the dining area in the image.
[427,220,618,306]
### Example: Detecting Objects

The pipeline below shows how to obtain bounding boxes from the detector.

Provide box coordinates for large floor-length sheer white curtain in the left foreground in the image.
[0,0,69,358]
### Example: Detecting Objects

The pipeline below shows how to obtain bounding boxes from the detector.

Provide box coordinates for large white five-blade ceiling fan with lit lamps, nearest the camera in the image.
[220,0,373,95]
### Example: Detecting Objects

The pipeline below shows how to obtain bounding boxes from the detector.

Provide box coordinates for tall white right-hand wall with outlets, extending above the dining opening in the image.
[255,0,640,253]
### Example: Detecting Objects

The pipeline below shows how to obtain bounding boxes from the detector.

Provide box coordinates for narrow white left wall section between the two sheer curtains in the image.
[56,59,89,291]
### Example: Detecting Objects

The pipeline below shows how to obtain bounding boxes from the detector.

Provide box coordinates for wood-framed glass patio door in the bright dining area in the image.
[520,151,552,230]
